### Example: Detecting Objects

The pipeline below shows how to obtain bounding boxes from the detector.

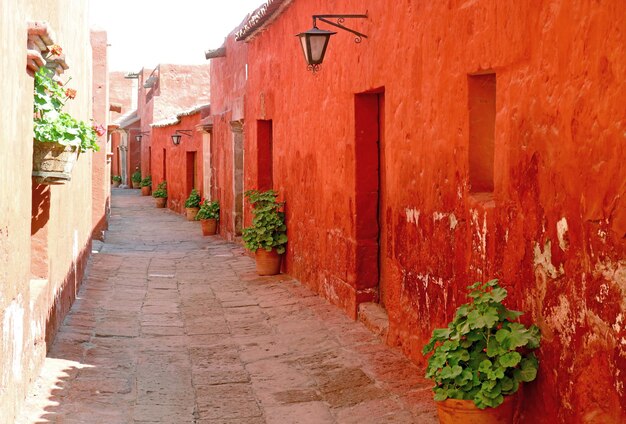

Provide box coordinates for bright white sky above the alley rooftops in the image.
[90,0,265,72]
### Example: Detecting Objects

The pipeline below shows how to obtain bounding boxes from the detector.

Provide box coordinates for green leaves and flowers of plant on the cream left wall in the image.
[33,64,106,152]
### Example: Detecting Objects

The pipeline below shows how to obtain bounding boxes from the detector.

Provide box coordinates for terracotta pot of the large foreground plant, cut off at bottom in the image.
[435,394,517,424]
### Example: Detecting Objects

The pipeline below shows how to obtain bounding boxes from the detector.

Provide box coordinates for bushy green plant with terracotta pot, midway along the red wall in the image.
[242,190,287,275]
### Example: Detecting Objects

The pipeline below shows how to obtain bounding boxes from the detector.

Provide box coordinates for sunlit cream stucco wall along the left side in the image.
[0,0,100,422]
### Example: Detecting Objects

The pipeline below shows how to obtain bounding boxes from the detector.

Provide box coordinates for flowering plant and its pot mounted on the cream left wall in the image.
[32,61,106,184]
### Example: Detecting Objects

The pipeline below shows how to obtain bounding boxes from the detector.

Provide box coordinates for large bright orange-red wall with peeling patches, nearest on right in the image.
[240,0,626,423]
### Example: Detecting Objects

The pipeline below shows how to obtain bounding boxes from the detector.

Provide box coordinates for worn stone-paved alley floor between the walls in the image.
[18,189,437,424]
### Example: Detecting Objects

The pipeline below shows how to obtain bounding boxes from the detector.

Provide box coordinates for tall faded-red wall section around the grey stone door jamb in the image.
[211,33,251,240]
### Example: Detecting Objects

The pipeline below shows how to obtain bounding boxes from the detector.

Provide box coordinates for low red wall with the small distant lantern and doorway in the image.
[151,112,204,213]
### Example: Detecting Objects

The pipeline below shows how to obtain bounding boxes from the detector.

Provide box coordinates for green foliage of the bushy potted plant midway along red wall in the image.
[242,190,287,254]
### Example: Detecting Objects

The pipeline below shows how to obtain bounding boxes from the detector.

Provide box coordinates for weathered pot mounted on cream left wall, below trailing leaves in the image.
[33,140,78,184]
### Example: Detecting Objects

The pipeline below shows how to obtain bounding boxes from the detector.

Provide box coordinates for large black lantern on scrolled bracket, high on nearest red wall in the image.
[296,15,367,73]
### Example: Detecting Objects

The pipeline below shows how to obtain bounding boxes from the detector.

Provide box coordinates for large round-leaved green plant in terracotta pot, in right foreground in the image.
[422,280,541,424]
